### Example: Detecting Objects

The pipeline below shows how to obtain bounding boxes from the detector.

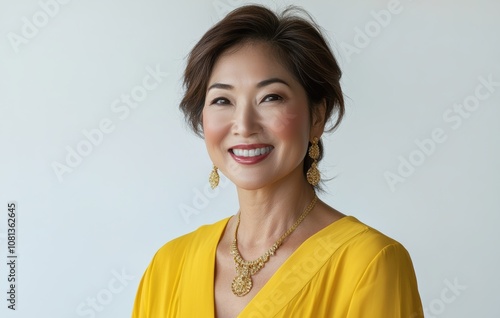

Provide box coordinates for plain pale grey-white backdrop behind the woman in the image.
[0,0,500,318]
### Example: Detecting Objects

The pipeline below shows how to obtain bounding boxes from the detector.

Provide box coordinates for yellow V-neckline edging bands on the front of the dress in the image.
[206,215,357,317]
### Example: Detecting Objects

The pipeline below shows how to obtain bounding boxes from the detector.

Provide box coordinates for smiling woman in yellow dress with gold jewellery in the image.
[133,6,423,318]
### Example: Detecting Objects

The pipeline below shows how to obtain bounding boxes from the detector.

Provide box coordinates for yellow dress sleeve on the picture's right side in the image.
[347,243,424,318]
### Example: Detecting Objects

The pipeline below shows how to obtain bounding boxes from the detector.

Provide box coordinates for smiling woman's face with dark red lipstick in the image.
[203,43,323,190]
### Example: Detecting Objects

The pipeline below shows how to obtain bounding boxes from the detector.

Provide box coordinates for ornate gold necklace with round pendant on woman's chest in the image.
[230,193,318,297]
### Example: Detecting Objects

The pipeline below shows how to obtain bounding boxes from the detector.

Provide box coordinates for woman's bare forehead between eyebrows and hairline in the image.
[209,42,294,85]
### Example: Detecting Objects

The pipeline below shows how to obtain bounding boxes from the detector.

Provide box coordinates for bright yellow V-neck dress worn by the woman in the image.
[132,216,424,318]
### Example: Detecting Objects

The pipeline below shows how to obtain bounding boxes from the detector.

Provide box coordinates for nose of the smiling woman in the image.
[232,101,262,137]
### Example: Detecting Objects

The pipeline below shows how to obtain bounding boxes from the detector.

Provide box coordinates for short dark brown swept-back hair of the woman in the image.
[180,5,345,188]
